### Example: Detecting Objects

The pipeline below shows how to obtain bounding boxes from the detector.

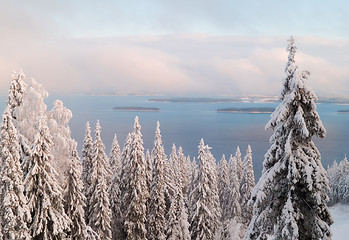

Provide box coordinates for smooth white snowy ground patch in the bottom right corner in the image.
[330,204,349,240]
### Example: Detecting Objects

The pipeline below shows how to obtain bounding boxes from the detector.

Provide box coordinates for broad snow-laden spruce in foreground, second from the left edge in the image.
[23,116,71,240]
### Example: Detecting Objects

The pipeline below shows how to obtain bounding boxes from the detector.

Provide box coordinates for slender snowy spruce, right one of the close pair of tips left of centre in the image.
[86,121,112,240]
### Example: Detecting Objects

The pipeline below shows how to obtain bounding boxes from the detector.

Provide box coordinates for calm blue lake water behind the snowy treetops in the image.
[1,95,349,179]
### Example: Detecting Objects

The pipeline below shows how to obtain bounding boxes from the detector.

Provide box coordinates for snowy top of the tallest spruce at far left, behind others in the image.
[7,71,27,119]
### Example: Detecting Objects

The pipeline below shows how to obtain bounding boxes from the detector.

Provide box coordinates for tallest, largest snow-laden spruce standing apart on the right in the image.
[245,39,333,240]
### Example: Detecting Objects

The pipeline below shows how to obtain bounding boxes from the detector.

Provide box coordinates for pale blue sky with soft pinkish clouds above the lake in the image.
[0,0,349,96]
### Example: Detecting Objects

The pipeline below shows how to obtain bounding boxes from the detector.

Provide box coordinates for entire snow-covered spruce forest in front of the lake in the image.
[0,37,338,240]
